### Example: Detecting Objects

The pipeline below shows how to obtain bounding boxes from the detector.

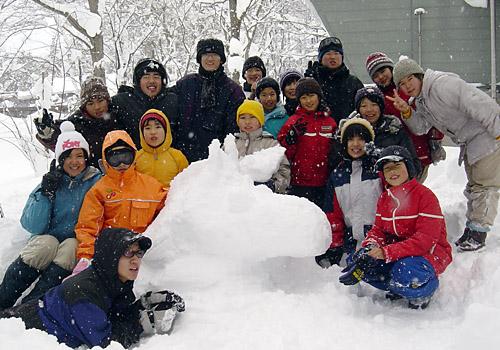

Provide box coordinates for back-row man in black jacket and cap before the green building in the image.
[304,37,363,124]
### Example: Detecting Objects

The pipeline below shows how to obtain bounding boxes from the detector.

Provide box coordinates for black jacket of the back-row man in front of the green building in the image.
[313,63,364,124]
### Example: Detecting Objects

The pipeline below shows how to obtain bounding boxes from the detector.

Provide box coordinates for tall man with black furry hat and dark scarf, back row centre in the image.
[173,39,245,163]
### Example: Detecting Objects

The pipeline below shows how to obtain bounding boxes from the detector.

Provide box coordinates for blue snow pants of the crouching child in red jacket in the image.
[363,256,439,300]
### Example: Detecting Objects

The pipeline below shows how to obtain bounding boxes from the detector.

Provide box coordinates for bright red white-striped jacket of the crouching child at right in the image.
[362,179,452,274]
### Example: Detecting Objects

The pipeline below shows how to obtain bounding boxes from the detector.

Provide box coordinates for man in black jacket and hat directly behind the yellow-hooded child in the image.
[111,58,178,148]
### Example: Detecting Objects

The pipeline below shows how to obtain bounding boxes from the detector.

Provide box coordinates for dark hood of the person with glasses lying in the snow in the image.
[92,228,152,291]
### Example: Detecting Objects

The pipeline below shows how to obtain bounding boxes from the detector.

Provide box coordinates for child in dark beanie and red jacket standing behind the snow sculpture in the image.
[278,78,337,207]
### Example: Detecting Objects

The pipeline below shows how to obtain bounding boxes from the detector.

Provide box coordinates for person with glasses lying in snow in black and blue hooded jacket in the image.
[0,228,185,348]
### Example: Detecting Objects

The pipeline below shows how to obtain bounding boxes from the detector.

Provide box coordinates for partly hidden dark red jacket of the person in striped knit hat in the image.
[379,83,444,167]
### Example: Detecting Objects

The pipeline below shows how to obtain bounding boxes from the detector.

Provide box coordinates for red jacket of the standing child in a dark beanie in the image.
[278,106,337,187]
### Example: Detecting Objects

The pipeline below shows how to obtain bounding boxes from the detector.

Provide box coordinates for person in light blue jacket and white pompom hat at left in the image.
[0,121,101,310]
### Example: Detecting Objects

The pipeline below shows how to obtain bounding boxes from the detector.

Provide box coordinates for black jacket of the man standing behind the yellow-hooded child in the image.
[111,86,178,149]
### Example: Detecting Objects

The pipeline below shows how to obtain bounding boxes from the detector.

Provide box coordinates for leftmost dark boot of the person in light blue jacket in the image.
[0,257,40,310]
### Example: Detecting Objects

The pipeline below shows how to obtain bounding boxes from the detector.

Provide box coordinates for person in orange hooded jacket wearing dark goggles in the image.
[73,130,167,274]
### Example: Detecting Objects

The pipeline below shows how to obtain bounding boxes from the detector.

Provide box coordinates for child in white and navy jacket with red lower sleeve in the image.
[316,118,382,268]
